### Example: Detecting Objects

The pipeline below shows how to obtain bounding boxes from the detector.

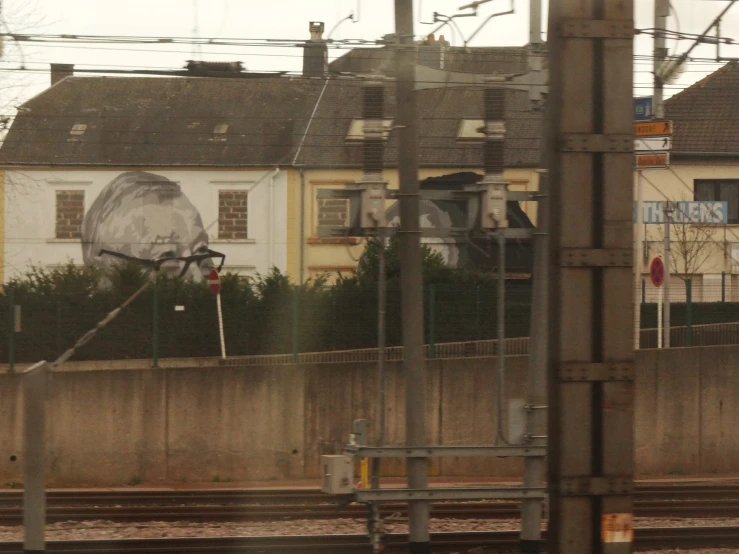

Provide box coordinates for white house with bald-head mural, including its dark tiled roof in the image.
[0,67,321,280]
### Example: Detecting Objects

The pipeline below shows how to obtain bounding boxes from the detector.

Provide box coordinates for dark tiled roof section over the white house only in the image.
[0,77,323,166]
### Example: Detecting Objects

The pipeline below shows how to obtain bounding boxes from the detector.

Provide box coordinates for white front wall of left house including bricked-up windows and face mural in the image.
[5,168,287,280]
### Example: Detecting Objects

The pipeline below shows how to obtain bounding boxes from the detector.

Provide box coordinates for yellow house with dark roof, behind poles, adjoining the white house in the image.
[287,79,541,282]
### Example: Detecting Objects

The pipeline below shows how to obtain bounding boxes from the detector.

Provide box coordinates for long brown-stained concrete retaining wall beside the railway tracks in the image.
[0,346,739,486]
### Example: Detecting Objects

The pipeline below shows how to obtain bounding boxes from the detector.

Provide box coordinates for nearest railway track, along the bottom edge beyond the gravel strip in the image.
[0,527,739,554]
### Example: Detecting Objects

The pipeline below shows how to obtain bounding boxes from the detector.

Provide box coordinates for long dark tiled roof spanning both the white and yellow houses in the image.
[0,71,541,168]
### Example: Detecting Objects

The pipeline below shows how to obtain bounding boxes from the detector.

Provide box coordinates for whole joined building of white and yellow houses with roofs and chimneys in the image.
[0,24,541,282]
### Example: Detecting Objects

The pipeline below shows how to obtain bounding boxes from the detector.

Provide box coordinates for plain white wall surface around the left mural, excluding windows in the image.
[4,169,287,281]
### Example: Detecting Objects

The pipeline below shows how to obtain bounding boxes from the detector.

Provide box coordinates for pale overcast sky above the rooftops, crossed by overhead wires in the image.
[0,0,739,110]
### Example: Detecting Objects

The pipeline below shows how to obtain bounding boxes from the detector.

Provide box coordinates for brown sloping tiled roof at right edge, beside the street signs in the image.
[665,62,739,155]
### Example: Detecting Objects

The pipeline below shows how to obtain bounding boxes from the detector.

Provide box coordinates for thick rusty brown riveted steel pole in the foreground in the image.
[545,4,634,554]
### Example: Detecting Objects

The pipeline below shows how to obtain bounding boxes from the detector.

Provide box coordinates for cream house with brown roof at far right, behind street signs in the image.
[635,62,739,301]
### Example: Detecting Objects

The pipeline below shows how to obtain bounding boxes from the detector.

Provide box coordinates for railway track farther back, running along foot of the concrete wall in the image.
[0,485,739,525]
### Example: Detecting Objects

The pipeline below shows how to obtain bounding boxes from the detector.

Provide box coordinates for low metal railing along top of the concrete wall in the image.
[225,323,739,365]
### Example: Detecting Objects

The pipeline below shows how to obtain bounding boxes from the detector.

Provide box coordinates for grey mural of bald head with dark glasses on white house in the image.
[82,171,212,281]
